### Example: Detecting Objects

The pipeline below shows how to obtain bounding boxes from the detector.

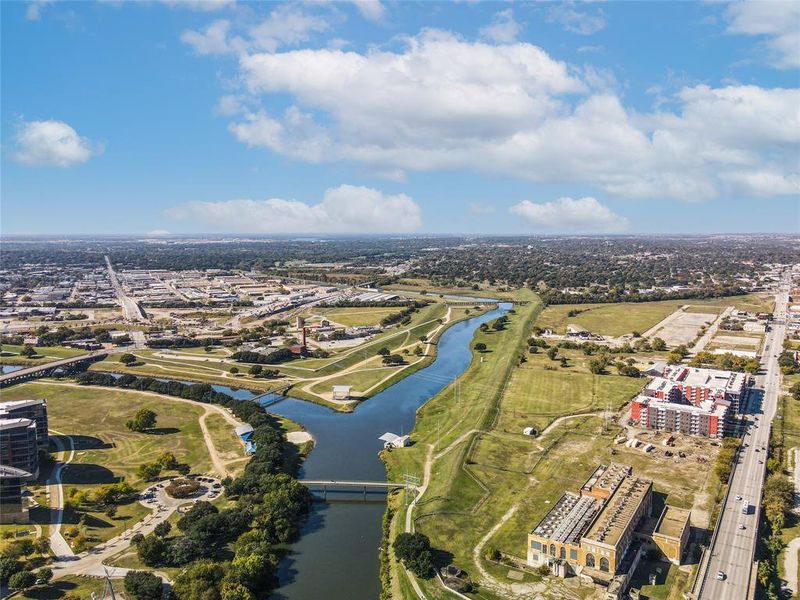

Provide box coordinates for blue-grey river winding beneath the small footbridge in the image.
[15,303,511,600]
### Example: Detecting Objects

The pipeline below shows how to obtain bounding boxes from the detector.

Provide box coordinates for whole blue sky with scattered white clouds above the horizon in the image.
[0,0,800,234]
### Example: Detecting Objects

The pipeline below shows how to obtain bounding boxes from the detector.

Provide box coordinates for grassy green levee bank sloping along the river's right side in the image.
[382,290,542,598]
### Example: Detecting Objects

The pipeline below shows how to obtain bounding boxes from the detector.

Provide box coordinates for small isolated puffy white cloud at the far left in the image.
[12,120,102,167]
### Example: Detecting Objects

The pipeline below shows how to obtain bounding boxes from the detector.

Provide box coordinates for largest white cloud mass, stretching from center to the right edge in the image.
[217,30,800,201]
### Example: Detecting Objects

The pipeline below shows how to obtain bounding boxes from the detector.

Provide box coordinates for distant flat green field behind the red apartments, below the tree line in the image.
[536,294,771,336]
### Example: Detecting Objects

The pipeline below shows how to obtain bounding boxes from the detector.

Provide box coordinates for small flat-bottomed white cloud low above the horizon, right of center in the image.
[509,196,630,233]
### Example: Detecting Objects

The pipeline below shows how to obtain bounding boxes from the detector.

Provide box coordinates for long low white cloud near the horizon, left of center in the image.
[166,185,422,234]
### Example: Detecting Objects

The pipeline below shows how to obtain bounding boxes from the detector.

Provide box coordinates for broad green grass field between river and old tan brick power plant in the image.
[385,288,717,600]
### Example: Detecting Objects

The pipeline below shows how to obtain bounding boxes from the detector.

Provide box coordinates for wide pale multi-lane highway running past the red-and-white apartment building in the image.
[697,278,789,600]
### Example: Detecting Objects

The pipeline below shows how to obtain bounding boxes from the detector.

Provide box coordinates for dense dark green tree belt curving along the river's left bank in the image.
[67,372,312,600]
